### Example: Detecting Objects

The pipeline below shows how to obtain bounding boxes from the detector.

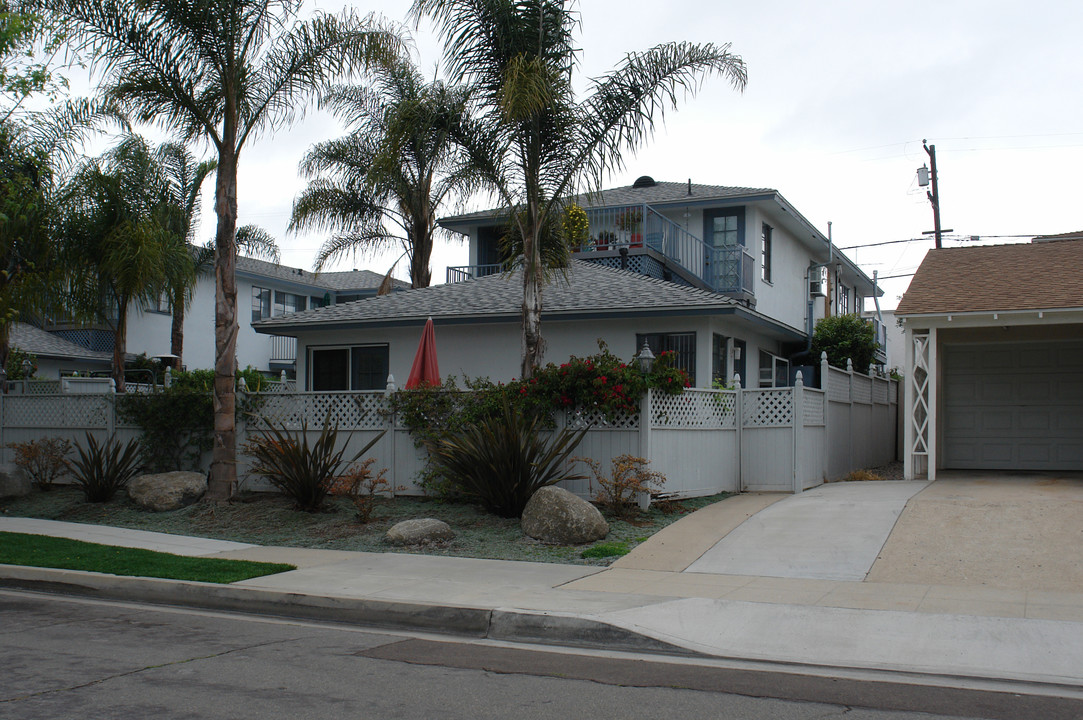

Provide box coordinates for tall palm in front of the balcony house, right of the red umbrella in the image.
[410,0,747,378]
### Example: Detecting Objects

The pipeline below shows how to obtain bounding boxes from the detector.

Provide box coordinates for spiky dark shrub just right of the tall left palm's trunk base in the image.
[243,415,387,512]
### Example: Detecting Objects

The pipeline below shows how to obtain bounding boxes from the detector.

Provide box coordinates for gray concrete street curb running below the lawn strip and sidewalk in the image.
[0,564,684,655]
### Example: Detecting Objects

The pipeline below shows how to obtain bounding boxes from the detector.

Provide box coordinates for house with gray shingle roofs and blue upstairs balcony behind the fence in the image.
[255,178,877,390]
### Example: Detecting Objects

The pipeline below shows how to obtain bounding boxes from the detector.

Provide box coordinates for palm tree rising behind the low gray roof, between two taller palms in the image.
[289,60,472,288]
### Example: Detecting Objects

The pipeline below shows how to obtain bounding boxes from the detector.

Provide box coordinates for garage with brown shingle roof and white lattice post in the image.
[896,234,1083,480]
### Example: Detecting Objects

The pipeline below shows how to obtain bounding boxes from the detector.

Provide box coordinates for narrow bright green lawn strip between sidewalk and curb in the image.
[0,533,297,582]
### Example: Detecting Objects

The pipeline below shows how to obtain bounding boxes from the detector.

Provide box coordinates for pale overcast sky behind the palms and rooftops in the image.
[124,0,1083,307]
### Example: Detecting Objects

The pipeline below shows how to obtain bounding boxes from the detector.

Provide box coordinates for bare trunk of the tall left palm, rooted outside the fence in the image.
[206,151,237,501]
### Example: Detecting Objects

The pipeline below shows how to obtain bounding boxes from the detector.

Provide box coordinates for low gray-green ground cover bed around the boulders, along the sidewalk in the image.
[0,486,729,565]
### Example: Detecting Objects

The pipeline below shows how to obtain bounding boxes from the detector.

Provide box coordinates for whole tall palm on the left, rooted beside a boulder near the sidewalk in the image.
[38,0,402,500]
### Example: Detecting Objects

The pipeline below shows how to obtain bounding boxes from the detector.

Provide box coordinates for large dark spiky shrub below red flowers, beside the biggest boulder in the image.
[427,401,589,518]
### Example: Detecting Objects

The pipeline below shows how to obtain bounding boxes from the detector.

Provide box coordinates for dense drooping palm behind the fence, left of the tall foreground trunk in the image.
[60,135,192,392]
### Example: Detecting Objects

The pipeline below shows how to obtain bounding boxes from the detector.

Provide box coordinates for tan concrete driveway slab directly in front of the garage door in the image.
[866,473,1083,592]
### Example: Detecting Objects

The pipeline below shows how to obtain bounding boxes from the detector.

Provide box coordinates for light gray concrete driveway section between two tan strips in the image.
[686,481,928,581]
